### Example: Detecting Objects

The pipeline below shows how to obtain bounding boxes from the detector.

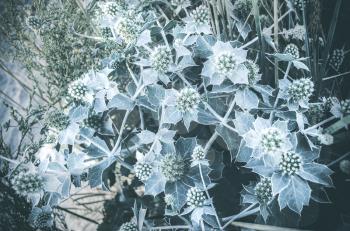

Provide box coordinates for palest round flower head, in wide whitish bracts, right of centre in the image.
[260,127,283,152]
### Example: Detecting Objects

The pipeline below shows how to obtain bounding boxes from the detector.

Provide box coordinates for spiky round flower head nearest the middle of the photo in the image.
[176,87,200,113]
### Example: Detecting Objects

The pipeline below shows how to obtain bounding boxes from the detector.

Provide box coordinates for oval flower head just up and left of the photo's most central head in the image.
[151,46,172,73]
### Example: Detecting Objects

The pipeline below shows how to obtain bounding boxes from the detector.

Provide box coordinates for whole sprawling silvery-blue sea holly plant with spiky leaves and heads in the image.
[5,0,350,230]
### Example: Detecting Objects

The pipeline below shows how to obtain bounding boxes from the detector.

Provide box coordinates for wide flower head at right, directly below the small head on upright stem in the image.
[288,78,314,101]
